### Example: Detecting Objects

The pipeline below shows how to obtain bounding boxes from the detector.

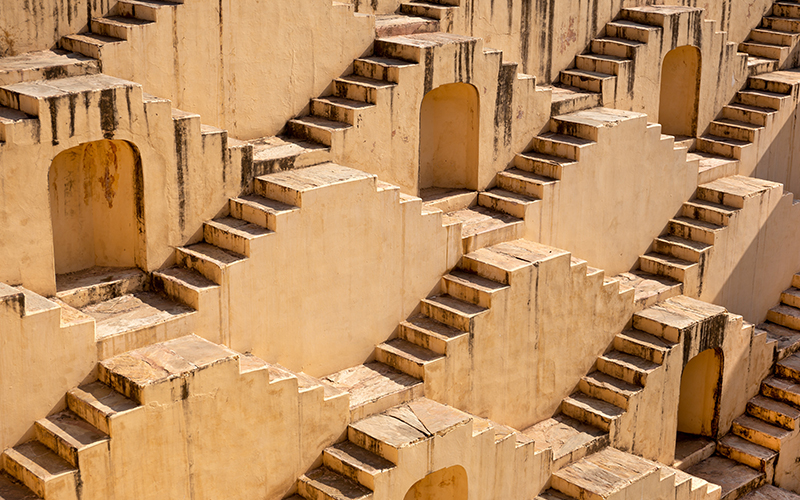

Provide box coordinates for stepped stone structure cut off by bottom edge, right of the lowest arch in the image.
[536,448,720,500]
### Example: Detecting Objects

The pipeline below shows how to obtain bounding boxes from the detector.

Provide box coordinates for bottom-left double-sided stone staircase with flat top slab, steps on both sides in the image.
[0,335,347,500]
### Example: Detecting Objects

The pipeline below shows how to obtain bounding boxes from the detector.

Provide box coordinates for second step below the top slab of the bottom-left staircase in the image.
[34,410,109,467]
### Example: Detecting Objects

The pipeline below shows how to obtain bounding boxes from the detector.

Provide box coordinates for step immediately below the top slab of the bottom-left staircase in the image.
[67,382,142,435]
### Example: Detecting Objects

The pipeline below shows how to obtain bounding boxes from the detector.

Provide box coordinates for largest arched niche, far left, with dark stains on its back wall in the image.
[48,140,143,274]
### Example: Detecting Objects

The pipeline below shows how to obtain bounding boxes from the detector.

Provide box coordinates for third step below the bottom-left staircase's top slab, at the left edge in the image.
[0,441,79,500]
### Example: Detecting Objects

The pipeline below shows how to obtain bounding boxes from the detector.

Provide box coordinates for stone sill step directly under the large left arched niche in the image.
[56,267,147,309]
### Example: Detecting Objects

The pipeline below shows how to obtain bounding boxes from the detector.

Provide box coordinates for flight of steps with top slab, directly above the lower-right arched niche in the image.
[639,175,782,297]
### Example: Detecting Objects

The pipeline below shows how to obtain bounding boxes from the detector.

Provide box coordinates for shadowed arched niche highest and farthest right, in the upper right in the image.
[658,45,701,137]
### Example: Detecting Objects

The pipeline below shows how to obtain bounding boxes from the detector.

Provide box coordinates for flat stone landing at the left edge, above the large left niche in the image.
[0,50,100,86]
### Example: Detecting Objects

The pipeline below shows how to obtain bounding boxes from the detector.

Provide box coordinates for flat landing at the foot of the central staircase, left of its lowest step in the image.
[324,362,424,421]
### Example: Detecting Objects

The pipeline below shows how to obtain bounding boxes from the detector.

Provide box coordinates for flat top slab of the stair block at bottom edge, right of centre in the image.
[551,448,660,500]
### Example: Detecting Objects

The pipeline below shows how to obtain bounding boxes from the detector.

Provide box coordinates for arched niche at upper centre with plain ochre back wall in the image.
[419,83,480,189]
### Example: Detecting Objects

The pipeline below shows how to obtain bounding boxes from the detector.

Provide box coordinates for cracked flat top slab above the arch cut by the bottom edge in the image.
[347,398,472,464]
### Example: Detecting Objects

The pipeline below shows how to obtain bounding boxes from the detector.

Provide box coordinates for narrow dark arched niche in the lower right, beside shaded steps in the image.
[678,349,723,438]
